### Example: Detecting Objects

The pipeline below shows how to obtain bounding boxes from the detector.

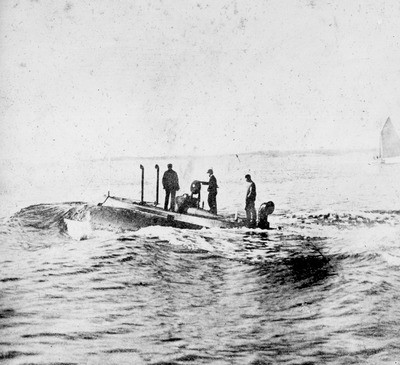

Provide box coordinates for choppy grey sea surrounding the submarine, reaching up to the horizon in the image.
[0,149,400,365]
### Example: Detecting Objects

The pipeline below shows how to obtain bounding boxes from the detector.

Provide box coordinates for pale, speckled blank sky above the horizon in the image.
[0,0,400,162]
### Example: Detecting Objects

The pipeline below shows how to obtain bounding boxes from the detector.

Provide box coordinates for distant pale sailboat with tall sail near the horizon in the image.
[379,117,400,163]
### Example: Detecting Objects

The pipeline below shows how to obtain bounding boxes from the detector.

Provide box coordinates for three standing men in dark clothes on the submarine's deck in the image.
[162,164,257,227]
